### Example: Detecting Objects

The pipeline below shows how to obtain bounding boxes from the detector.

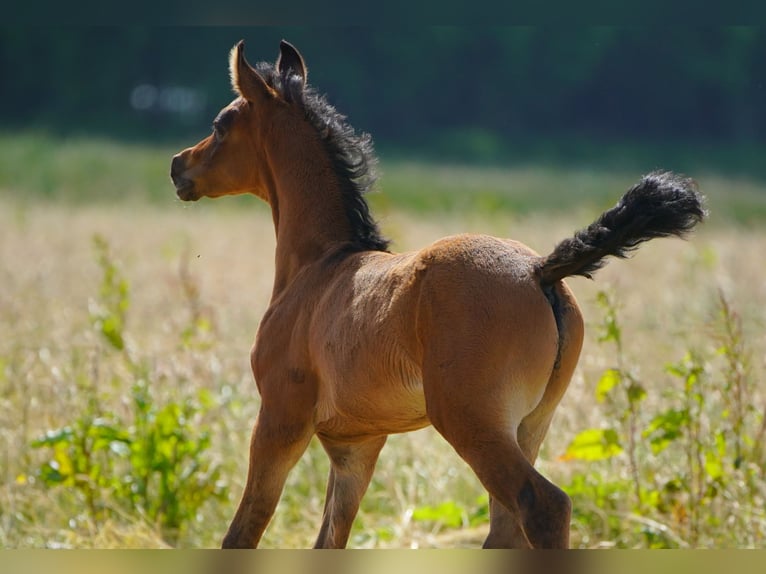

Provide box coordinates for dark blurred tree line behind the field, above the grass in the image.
[0,26,766,177]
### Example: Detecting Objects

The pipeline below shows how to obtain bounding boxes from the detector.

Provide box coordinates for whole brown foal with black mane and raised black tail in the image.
[170,40,706,548]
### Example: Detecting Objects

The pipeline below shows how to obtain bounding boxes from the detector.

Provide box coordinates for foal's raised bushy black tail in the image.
[539,171,706,286]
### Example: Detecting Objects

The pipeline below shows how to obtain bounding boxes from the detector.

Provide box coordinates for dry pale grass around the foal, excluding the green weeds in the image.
[0,199,766,547]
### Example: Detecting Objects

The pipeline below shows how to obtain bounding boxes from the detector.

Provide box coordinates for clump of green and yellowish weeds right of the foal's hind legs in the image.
[562,292,766,548]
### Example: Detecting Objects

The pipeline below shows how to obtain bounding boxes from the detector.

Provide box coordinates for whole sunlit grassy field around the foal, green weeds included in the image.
[0,134,766,548]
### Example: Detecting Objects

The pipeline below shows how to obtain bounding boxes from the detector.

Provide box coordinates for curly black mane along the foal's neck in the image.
[256,62,389,251]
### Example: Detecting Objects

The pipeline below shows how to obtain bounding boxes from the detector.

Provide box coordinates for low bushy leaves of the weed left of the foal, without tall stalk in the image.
[32,382,227,544]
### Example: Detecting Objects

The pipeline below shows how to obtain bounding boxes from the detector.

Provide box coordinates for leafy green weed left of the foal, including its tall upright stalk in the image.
[31,236,227,544]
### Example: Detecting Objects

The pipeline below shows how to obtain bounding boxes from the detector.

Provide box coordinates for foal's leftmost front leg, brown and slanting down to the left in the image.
[222,409,313,548]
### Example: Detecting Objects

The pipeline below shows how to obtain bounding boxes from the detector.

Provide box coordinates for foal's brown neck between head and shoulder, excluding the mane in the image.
[269,137,352,297]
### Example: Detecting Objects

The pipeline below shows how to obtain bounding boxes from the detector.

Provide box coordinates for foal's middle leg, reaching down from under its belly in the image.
[314,436,387,548]
